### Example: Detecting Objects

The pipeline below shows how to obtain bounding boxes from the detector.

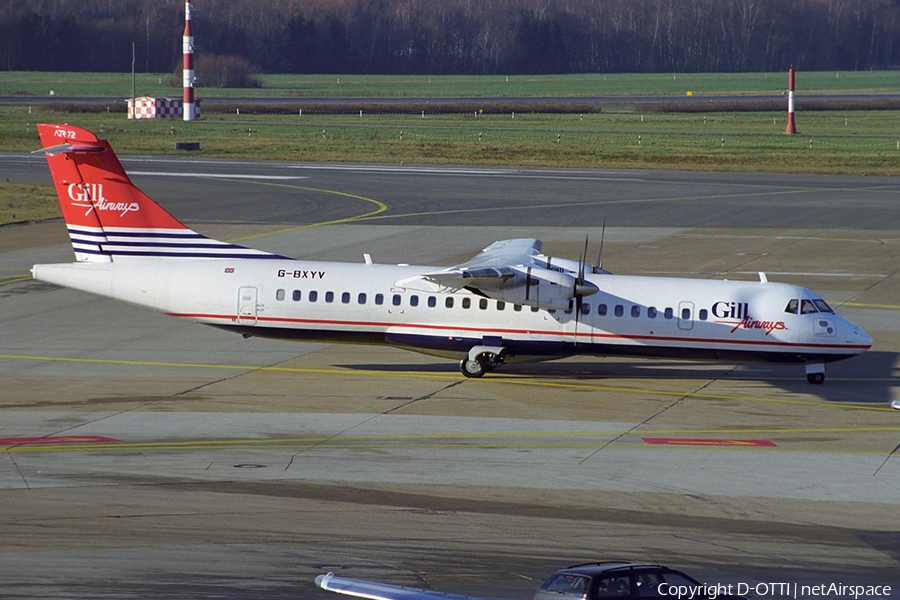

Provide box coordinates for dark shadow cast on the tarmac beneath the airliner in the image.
[336,351,900,404]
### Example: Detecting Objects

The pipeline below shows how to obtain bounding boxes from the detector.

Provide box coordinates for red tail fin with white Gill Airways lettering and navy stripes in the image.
[37,125,283,262]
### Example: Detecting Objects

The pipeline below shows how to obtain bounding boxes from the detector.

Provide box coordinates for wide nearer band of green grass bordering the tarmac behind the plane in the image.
[0,107,900,175]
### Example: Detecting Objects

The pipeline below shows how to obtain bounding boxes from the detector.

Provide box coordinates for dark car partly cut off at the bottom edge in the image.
[534,562,744,600]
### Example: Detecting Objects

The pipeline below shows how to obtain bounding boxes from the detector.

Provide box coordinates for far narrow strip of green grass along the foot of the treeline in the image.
[0,71,900,99]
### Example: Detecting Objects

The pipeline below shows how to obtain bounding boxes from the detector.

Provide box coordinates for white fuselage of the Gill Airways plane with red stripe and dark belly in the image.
[34,258,872,363]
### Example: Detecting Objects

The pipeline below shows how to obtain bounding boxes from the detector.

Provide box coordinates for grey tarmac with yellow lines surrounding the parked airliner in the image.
[0,154,900,599]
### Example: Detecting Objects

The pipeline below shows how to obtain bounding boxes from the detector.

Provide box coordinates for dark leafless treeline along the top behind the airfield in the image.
[7,0,900,74]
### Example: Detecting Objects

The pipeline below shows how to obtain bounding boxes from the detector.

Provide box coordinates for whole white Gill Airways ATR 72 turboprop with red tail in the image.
[32,125,872,383]
